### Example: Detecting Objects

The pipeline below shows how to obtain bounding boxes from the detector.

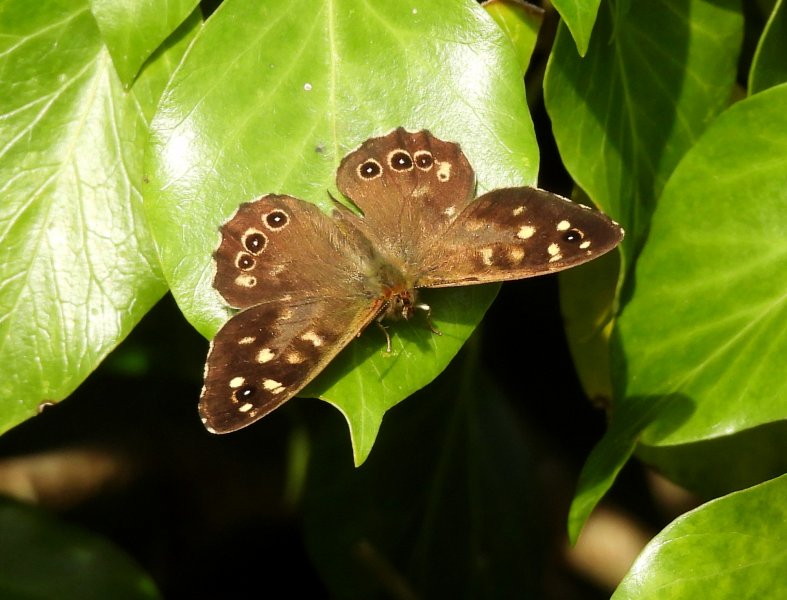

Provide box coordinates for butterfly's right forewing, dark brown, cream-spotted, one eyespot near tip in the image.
[415,187,623,287]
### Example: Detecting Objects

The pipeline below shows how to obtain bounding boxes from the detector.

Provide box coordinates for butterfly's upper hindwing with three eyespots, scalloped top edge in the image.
[336,128,475,264]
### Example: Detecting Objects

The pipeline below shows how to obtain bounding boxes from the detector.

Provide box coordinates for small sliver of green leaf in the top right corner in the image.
[749,0,787,94]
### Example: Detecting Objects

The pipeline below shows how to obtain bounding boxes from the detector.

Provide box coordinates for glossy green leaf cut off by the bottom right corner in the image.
[612,475,787,600]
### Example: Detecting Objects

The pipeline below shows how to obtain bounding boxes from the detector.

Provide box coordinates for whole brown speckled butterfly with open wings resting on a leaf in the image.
[199,128,623,433]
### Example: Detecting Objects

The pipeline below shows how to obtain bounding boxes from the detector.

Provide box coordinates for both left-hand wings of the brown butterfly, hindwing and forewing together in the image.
[199,196,382,433]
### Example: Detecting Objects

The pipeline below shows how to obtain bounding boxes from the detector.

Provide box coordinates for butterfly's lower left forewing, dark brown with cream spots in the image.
[199,296,380,433]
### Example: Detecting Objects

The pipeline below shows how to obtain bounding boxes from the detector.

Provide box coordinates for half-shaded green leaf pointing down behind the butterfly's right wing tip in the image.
[544,0,743,253]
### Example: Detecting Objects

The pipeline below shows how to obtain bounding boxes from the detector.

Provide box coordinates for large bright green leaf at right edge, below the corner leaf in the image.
[619,85,787,445]
